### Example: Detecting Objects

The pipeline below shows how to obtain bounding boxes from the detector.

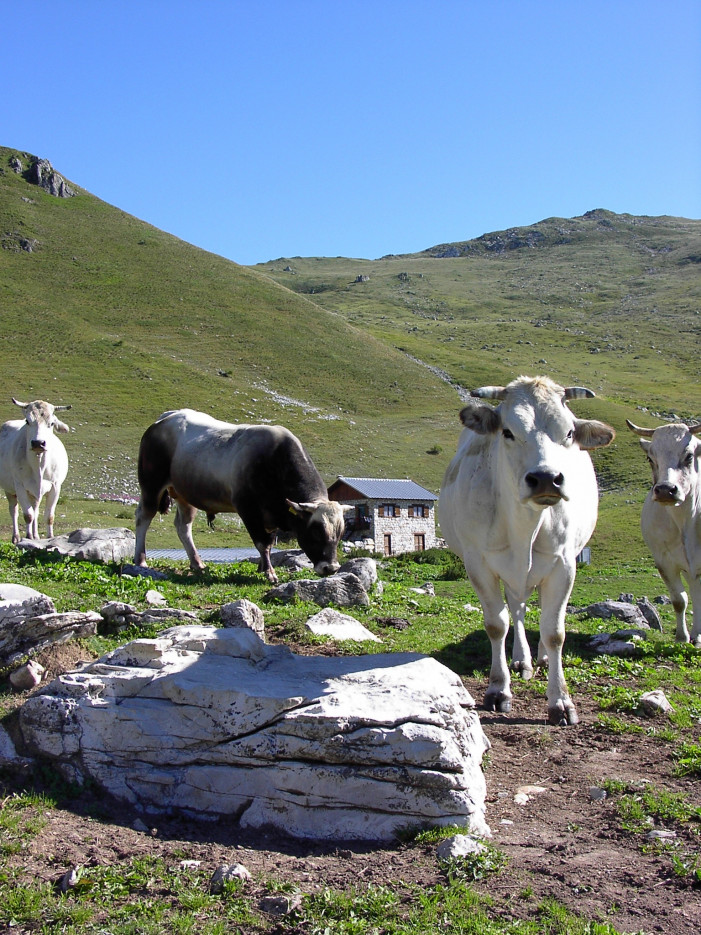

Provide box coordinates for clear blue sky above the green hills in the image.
[0,0,701,264]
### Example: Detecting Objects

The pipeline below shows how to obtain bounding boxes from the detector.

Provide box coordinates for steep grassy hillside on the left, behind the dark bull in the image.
[0,148,458,496]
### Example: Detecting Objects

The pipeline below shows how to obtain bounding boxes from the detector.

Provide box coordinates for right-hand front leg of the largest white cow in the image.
[540,562,579,727]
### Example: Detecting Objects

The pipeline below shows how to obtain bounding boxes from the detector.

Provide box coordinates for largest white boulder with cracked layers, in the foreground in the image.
[20,626,489,840]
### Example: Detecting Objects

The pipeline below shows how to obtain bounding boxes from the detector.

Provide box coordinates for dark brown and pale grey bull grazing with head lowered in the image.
[134,409,344,583]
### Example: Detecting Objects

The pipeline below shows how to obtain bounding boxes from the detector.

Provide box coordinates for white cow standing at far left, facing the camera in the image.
[0,397,71,542]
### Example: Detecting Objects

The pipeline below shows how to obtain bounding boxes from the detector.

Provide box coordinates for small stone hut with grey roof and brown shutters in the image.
[329,477,439,555]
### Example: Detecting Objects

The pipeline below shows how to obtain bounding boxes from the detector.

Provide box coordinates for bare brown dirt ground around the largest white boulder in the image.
[5,646,701,935]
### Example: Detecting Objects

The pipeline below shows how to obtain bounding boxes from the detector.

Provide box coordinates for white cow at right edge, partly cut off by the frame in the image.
[626,419,701,649]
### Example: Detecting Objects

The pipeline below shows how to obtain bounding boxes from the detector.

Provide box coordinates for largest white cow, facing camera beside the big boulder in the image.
[439,377,615,725]
